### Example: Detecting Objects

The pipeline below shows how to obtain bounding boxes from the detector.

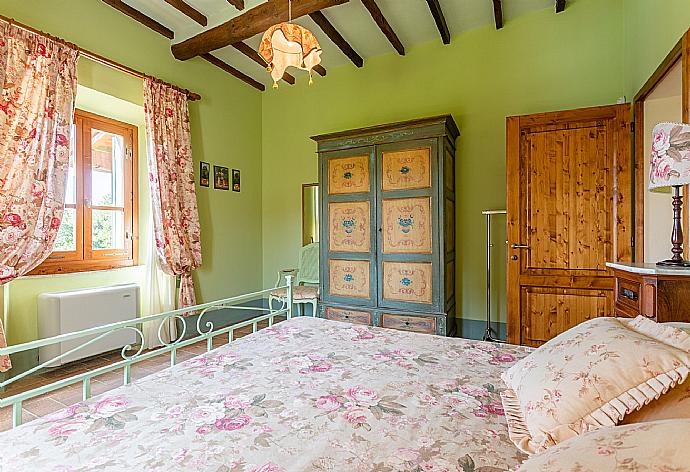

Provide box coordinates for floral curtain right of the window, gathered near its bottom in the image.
[144,79,201,308]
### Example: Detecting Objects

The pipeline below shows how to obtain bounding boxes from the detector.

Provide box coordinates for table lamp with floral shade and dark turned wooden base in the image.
[649,123,690,268]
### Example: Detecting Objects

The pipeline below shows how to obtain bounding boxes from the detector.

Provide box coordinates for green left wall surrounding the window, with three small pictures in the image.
[0,0,262,370]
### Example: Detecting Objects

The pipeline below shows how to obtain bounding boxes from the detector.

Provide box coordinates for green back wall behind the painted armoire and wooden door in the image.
[262,0,626,319]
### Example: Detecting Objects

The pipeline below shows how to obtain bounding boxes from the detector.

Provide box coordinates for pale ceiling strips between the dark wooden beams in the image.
[124,0,552,85]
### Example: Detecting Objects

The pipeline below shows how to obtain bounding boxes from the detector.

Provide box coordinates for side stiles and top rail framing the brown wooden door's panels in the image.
[506,104,633,344]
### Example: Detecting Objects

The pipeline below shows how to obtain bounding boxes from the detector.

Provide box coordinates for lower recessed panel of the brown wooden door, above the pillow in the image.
[522,287,613,347]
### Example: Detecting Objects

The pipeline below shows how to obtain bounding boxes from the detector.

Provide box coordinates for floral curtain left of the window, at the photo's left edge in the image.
[0,21,78,372]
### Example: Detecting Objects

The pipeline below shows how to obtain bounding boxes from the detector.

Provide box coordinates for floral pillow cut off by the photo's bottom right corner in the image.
[517,420,690,472]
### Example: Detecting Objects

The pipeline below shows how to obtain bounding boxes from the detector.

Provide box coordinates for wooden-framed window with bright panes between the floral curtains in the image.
[31,110,138,274]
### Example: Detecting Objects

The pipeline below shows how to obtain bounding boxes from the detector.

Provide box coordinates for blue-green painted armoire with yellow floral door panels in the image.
[312,115,460,336]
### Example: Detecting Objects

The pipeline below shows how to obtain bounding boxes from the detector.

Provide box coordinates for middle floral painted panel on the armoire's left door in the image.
[328,201,371,252]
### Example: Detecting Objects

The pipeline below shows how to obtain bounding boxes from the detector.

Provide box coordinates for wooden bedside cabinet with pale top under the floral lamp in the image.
[606,263,690,323]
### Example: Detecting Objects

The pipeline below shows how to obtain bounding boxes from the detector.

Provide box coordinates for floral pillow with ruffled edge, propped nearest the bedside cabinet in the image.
[501,317,690,454]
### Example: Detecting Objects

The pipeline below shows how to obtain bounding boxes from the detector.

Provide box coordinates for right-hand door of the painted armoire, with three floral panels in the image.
[376,139,442,312]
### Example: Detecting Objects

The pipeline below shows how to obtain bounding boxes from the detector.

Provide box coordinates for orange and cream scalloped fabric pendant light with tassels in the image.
[259,0,322,88]
